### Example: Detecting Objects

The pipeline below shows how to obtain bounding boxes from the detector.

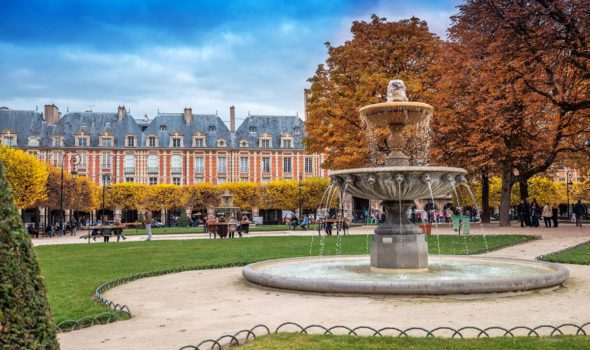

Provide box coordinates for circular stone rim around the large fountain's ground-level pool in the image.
[242,255,569,295]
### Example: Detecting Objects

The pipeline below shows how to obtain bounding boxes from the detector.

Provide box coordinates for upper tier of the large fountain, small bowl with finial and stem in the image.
[360,80,434,166]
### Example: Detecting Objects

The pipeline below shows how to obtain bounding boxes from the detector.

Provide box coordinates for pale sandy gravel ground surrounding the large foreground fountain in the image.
[59,225,590,350]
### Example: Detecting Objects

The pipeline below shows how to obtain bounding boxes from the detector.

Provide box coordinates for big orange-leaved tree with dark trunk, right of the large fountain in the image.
[433,0,590,226]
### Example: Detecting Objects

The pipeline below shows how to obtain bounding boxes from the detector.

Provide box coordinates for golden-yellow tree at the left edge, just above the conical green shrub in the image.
[0,146,48,208]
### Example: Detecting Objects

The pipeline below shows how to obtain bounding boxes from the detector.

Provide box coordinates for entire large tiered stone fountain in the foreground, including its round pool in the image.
[243,80,569,294]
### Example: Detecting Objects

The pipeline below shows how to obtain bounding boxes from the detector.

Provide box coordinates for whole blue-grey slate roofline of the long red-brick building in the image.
[0,108,305,149]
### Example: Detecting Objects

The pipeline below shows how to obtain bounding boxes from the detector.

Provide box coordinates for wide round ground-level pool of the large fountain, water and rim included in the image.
[242,255,569,295]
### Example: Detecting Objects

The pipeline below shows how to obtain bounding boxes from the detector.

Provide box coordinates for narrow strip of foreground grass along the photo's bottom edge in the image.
[239,333,590,350]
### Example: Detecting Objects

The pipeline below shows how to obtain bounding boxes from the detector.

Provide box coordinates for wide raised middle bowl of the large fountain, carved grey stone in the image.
[330,166,467,201]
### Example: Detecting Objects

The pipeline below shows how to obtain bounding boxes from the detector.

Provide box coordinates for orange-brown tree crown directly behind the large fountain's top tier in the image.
[304,15,439,169]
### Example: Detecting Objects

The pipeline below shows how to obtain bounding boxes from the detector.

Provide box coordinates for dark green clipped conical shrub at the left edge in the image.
[0,162,59,349]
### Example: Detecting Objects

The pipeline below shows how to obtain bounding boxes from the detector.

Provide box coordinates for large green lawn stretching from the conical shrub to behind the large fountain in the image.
[35,235,534,323]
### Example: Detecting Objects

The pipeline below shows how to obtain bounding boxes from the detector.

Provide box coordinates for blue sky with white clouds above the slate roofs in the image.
[0,0,459,119]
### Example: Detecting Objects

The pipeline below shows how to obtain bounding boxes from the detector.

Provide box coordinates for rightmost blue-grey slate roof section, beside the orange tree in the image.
[235,115,305,149]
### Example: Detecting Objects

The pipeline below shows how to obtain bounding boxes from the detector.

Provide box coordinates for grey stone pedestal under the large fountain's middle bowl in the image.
[371,200,428,272]
